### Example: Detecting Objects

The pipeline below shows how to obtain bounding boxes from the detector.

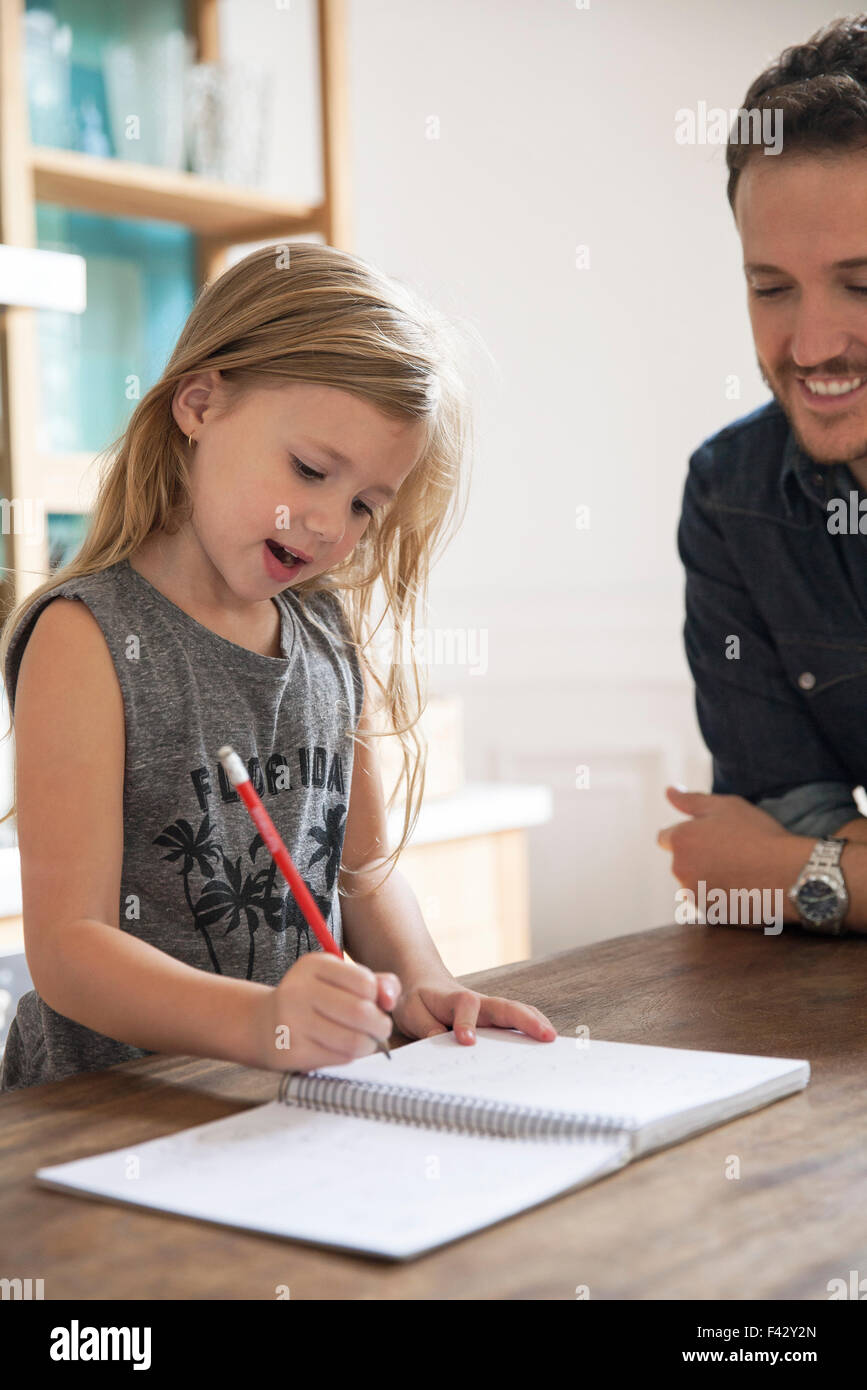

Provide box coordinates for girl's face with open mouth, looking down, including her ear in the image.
[172,373,424,602]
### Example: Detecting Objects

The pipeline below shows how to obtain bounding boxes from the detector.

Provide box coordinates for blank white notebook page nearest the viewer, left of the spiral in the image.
[38,1101,629,1259]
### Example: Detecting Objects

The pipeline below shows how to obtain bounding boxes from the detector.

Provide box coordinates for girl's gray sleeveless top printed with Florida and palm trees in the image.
[0,560,364,1090]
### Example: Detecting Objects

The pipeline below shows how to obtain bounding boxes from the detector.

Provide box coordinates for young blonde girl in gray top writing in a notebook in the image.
[0,243,556,1090]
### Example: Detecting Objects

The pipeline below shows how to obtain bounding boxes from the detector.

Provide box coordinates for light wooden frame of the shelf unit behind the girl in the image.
[0,0,352,614]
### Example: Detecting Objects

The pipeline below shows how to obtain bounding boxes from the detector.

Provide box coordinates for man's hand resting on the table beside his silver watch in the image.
[656,787,816,922]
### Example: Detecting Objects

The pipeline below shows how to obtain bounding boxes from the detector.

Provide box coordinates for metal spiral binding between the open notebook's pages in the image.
[278,1072,635,1140]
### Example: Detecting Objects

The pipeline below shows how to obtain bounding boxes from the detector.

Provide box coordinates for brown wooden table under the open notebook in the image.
[0,926,867,1300]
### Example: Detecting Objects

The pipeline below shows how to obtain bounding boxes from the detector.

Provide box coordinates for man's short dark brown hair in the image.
[725,14,867,211]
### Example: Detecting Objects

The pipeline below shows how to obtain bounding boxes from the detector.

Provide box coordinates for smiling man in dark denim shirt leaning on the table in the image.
[659,15,867,934]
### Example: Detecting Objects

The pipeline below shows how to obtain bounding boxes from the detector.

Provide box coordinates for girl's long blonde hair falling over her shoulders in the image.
[0,242,472,895]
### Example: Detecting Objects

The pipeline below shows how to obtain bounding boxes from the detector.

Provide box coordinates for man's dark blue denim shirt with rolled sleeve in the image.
[678,400,867,835]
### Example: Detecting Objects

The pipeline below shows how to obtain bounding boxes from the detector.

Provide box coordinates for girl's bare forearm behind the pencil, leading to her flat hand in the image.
[340,869,452,990]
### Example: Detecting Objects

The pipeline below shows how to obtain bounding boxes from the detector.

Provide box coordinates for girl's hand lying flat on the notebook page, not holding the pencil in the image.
[392,976,557,1044]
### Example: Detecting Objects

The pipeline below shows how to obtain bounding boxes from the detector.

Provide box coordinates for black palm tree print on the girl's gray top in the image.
[153,803,346,980]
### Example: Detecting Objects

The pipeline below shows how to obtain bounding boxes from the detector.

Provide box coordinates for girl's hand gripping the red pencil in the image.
[257,951,391,1072]
